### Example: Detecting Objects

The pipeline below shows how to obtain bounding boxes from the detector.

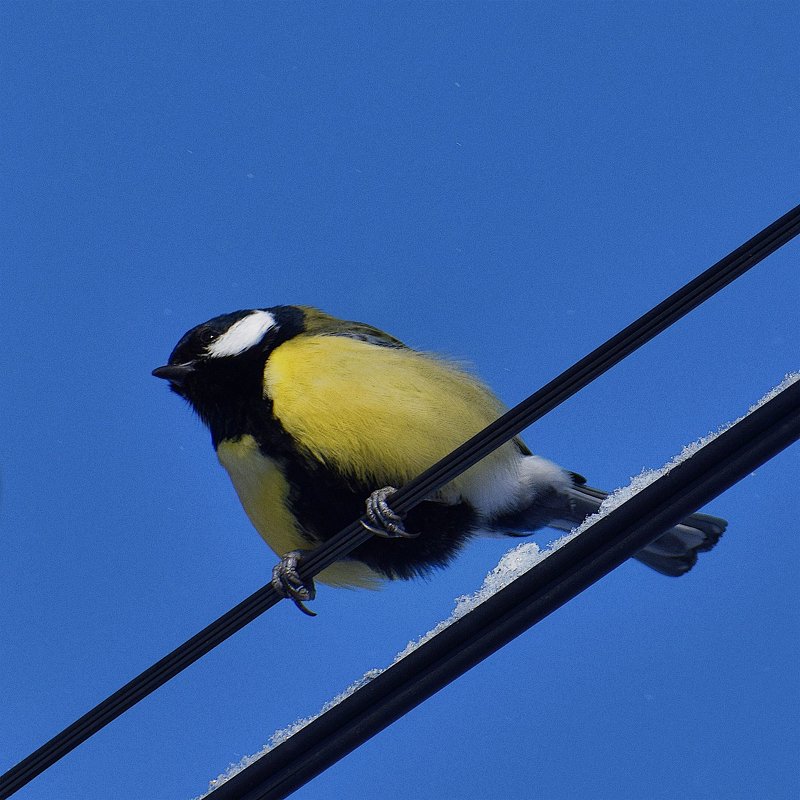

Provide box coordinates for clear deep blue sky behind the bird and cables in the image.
[0,2,800,800]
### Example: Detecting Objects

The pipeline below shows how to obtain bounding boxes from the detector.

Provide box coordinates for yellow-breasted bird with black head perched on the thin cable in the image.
[153,305,727,615]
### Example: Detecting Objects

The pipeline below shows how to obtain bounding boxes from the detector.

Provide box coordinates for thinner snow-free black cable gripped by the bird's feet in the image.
[0,206,800,800]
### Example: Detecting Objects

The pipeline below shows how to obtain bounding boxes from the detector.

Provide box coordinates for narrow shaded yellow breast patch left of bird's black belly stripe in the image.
[217,435,380,588]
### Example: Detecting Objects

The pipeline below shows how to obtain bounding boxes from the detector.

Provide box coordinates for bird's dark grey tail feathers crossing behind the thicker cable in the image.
[548,484,728,577]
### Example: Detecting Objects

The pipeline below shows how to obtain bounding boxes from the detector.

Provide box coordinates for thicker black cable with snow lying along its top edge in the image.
[206,381,800,800]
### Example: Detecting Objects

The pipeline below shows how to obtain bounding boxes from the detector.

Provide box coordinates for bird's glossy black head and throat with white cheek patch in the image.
[153,306,304,444]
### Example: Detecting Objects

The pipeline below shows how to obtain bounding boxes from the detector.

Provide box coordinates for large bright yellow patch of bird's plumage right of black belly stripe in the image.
[264,335,514,496]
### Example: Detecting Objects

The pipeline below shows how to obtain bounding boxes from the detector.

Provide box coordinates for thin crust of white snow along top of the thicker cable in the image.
[195,372,800,800]
